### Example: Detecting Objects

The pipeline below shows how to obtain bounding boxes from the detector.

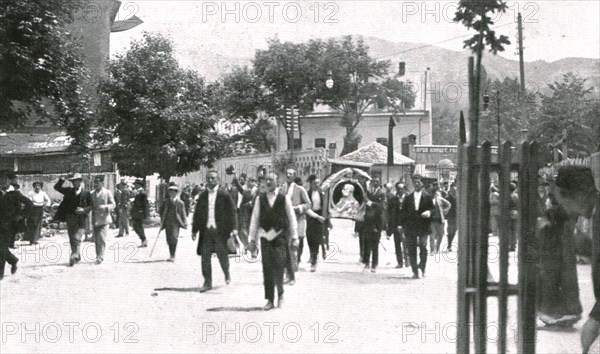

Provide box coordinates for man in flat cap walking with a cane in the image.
[160,182,187,262]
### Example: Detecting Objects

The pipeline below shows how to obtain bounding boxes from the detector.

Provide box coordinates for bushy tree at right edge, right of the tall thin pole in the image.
[534,73,600,160]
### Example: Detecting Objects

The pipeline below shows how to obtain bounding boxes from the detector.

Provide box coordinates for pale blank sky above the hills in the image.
[111,0,600,61]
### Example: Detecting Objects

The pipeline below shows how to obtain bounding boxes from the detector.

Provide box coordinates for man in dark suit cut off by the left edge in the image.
[0,174,33,280]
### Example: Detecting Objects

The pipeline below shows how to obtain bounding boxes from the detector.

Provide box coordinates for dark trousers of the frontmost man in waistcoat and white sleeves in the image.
[260,235,289,302]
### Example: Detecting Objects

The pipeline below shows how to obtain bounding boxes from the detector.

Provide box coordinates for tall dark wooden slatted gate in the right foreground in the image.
[457,115,538,354]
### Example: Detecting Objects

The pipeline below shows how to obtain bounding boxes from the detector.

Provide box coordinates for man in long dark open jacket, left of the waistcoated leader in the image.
[192,171,237,292]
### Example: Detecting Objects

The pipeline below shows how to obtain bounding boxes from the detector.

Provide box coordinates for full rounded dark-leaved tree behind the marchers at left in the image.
[97,33,224,182]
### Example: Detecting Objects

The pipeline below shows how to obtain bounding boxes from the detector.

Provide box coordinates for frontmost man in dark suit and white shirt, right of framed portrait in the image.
[402,174,435,279]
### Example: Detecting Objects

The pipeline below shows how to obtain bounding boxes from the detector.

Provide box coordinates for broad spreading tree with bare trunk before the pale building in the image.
[254,36,415,155]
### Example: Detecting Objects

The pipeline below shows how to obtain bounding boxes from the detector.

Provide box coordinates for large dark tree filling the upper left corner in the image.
[0,0,92,150]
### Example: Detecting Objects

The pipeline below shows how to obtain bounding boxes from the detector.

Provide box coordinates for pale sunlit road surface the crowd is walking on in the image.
[0,220,600,353]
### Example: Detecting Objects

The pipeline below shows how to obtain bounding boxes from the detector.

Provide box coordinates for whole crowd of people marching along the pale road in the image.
[0,166,600,346]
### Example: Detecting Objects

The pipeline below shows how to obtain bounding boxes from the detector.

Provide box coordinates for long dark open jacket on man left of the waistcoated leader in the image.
[192,188,238,256]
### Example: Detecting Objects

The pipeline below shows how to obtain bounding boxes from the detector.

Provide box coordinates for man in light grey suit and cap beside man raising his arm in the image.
[91,175,116,264]
